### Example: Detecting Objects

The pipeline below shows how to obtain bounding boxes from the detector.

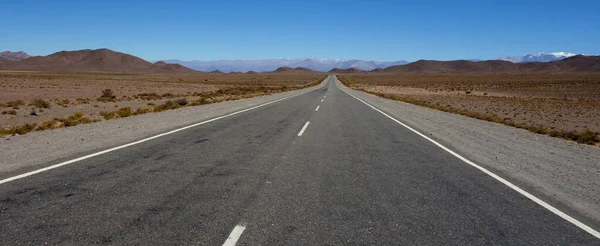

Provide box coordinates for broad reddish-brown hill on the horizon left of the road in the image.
[0,49,195,73]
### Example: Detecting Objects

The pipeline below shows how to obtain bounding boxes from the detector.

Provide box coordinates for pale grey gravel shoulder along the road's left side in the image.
[0,80,325,179]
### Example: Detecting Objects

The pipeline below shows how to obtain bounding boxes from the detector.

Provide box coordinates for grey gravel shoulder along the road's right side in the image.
[337,76,600,228]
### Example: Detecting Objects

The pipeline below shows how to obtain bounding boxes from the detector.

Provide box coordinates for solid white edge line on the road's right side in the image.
[342,77,600,238]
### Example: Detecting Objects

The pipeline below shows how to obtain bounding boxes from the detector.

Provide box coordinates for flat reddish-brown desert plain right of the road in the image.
[339,74,600,145]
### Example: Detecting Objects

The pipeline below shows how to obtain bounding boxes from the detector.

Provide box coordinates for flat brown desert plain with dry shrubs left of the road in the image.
[0,71,325,136]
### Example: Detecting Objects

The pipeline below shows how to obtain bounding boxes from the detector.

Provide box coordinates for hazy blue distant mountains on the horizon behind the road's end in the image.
[165,57,408,73]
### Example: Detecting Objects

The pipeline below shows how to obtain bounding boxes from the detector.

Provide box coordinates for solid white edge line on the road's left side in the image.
[0,87,318,184]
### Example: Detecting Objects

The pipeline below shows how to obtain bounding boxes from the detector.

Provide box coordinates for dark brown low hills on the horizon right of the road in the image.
[382,55,600,74]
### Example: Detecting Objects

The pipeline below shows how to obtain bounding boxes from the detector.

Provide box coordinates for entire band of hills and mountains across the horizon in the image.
[0,49,600,74]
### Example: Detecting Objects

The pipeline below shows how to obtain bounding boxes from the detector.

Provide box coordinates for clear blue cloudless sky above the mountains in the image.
[0,0,600,61]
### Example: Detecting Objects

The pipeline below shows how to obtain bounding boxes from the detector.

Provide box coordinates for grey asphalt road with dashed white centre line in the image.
[0,77,600,245]
